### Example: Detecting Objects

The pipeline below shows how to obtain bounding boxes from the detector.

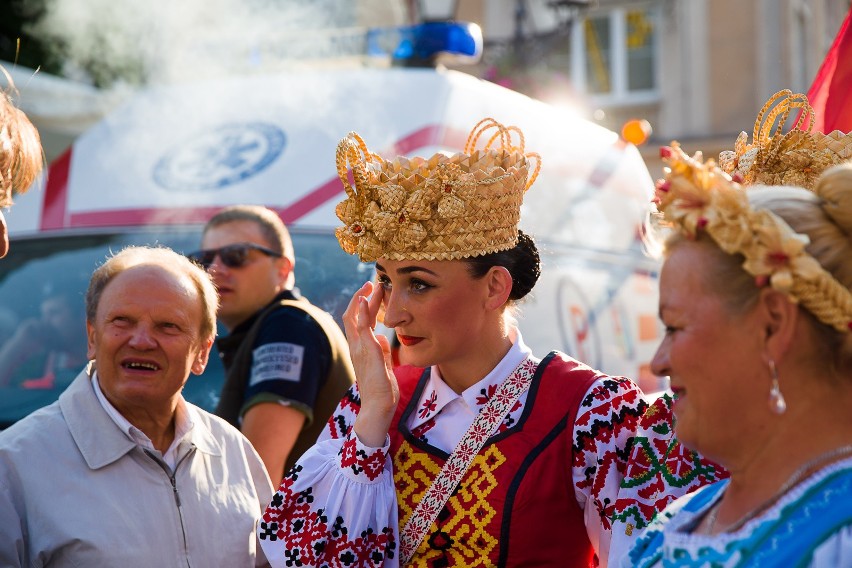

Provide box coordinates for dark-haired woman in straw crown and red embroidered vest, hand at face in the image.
[258,119,646,567]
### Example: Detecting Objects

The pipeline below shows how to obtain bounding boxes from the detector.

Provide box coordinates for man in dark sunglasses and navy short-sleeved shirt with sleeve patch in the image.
[190,205,354,483]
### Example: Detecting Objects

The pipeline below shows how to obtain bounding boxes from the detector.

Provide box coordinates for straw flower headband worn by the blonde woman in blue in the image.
[654,142,852,332]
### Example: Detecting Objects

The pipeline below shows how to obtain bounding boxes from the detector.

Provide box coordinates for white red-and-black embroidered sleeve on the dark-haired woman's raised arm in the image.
[258,386,399,568]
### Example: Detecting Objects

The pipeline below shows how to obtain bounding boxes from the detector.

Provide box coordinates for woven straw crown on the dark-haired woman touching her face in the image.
[336,118,541,262]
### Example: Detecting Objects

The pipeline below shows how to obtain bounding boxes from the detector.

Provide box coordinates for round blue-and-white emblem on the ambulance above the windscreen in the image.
[154,122,286,191]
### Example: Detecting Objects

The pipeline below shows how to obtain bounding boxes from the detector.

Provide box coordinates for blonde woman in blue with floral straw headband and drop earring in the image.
[612,91,852,567]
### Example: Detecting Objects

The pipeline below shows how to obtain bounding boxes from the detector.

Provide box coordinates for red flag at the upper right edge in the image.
[808,8,852,134]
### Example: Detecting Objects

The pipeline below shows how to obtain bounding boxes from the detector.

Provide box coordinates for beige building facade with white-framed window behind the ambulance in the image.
[432,0,850,176]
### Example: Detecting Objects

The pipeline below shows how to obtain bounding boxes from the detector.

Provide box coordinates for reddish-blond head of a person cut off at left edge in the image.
[0,66,44,258]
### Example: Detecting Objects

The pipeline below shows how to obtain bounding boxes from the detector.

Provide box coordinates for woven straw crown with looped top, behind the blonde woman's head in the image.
[719,89,852,189]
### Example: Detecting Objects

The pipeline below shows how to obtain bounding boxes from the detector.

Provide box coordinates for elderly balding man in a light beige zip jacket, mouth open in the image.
[0,247,272,568]
